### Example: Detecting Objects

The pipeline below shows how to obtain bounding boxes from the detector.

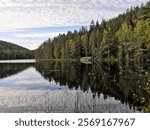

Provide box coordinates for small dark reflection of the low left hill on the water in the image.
[0,63,33,79]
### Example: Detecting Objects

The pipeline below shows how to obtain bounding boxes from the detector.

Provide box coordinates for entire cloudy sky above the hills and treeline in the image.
[0,0,148,49]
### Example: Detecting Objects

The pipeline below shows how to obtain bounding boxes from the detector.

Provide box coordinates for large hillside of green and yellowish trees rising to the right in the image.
[35,2,150,61]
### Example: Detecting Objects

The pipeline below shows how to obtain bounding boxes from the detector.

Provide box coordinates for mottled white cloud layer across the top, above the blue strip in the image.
[0,0,147,28]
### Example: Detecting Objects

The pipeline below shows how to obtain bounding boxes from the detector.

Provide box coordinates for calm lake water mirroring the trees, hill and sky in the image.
[0,60,150,113]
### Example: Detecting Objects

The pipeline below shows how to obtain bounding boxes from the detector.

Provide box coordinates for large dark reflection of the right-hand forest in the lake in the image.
[36,61,150,112]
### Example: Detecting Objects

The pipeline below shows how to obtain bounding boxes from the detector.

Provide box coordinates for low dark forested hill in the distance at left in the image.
[0,41,34,60]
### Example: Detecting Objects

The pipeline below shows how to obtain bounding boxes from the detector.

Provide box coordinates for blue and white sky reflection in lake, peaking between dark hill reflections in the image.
[0,67,66,90]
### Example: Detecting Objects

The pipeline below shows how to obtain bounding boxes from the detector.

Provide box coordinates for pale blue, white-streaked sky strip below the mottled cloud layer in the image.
[0,25,82,50]
